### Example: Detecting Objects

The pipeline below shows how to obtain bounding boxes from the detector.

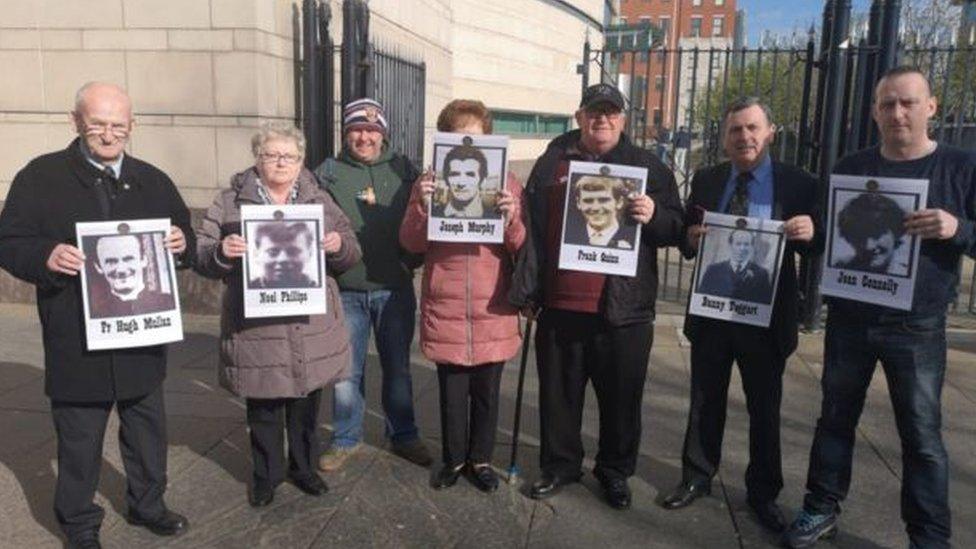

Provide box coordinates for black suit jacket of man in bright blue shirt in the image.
[681,161,824,359]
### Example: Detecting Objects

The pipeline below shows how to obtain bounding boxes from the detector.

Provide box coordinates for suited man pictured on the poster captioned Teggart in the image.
[698,229,773,303]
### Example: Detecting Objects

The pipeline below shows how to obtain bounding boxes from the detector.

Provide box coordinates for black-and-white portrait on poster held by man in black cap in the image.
[565,174,638,250]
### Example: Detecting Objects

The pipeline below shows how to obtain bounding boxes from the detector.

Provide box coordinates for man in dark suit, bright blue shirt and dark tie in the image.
[662,98,823,531]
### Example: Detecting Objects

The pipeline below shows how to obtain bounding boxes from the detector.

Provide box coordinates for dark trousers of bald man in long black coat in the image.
[51,386,166,541]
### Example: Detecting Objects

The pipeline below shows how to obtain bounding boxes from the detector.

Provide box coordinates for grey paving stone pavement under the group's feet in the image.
[0,305,976,548]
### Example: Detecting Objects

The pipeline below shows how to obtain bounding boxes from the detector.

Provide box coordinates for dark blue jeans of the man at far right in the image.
[804,314,951,547]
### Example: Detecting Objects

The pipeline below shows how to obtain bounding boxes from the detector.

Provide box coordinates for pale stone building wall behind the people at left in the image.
[0,0,617,300]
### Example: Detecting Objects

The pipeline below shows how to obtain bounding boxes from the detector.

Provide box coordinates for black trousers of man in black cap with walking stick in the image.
[535,309,654,478]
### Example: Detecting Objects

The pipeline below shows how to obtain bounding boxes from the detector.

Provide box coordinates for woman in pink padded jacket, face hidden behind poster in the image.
[400,99,525,492]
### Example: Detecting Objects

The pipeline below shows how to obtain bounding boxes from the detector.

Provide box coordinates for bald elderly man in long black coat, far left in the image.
[0,82,195,548]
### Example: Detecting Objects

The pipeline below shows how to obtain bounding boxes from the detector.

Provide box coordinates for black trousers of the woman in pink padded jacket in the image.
[437,362,505,467]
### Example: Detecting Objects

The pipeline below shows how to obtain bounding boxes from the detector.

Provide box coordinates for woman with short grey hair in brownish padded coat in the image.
[195,124,362,507]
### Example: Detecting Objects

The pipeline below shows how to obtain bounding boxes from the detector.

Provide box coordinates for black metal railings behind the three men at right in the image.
[581,6,976,314]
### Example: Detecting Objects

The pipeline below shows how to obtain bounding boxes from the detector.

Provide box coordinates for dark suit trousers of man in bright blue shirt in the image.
[681,320,786,503]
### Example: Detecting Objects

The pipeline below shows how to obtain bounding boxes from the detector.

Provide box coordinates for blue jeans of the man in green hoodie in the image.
[332,286,420,448]
